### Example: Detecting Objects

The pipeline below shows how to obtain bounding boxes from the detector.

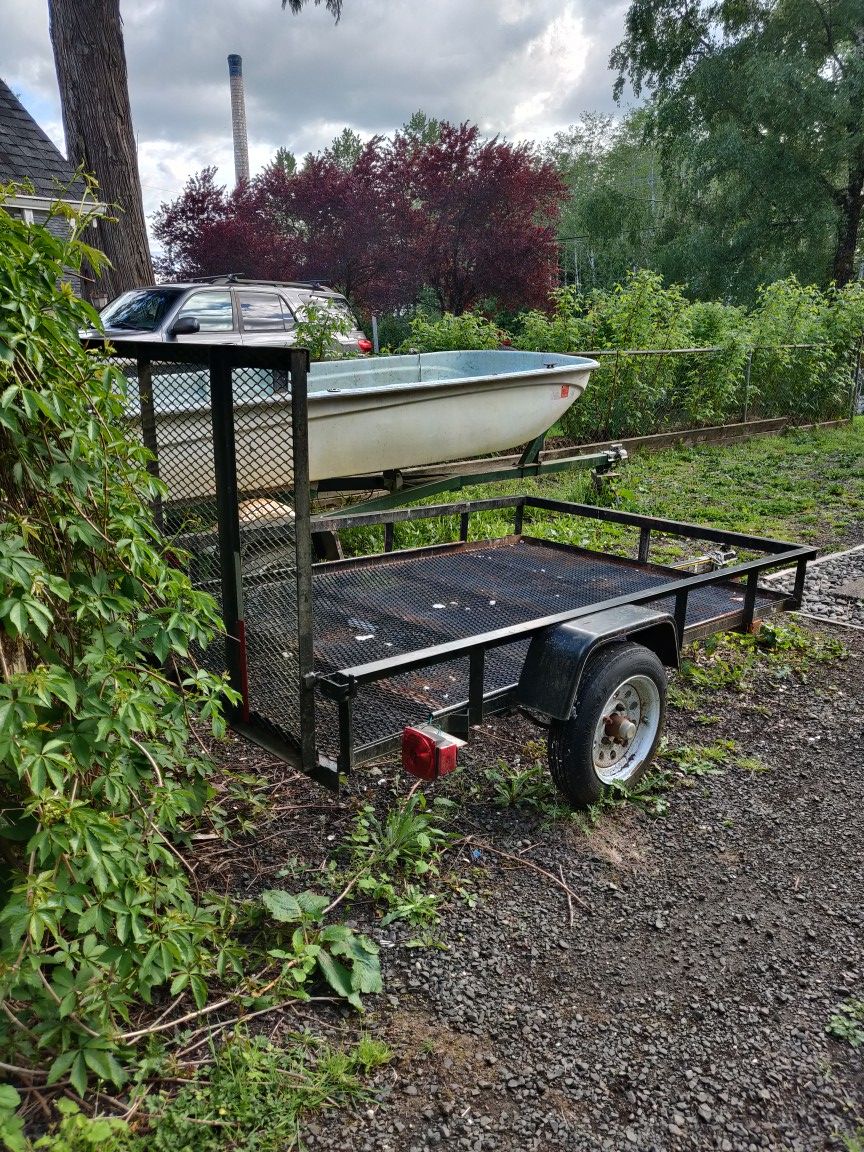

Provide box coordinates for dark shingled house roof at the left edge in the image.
[0,79,85,203]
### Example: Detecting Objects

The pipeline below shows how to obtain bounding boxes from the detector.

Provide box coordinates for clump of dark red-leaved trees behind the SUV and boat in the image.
[154,123,564,313]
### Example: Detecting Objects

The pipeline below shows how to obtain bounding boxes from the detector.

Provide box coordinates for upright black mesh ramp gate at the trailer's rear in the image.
[90,342,316,771]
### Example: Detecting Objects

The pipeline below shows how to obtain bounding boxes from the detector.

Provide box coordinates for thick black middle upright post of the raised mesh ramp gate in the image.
[210,346,249,720]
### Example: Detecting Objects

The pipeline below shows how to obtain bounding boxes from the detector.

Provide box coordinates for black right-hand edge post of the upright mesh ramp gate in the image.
[287,349,317,772]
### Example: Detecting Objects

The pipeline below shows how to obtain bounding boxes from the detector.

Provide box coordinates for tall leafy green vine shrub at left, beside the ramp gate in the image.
[0,198,233,1093]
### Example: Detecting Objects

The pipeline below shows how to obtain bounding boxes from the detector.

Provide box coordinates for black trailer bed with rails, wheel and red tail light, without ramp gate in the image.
[304,495,814,805]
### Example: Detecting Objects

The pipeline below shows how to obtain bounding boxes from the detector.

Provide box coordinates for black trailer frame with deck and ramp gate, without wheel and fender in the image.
[93,341,816,788]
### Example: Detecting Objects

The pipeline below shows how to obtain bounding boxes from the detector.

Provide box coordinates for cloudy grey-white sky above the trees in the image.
[0,0,627,229]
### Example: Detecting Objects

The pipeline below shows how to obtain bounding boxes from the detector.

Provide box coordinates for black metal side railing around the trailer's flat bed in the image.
[312,495,816,780]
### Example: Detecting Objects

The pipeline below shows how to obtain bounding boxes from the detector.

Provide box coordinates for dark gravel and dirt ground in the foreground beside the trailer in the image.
[212,629,864,1152]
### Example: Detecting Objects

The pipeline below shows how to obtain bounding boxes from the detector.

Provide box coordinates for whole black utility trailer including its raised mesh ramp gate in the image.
[97,343,816,804]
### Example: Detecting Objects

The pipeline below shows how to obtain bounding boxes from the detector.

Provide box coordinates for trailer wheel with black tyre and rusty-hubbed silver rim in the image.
[548,643,666,808]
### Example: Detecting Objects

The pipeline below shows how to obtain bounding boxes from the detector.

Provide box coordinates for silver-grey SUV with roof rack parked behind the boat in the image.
[99,275,372,354]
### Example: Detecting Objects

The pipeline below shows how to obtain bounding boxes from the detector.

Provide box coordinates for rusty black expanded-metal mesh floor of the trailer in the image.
[312,537,775,755]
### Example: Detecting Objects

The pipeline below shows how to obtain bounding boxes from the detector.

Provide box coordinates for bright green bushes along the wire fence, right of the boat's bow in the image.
[514,270,864,442]
